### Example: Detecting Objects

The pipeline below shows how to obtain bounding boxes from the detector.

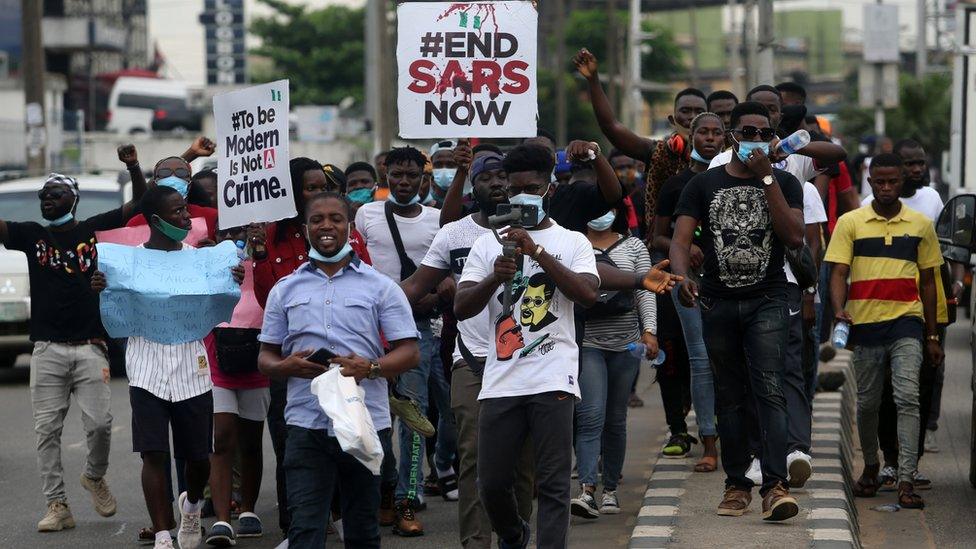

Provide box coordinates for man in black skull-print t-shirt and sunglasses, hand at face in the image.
[670,101,804,521]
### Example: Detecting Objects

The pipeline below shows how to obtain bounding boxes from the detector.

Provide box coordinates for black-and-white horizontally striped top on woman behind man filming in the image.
[583,236,657,351]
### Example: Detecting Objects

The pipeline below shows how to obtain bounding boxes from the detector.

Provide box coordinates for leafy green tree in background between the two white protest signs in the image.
[250,0,365,105]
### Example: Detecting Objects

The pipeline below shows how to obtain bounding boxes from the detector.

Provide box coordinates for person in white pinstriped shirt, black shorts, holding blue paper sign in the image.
[91,185,244,549]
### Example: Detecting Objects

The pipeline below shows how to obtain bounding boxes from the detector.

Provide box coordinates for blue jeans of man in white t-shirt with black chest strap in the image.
[396,320,457,501]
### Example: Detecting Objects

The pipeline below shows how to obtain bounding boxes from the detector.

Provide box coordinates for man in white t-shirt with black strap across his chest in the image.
[356,147,446,537]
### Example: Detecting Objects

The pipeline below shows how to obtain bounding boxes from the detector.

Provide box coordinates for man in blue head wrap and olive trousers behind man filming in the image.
[401,152,533,549]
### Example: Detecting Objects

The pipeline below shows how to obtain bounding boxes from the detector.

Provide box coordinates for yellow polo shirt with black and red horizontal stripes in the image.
[824,205,942,345]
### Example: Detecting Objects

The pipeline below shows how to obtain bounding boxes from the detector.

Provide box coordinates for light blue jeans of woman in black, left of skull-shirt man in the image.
[671,286,718,437]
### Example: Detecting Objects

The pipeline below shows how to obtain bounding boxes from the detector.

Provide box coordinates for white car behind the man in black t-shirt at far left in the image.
[0,174,131,372]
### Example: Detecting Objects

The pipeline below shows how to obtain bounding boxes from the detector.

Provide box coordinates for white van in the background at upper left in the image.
[105,76,188,134]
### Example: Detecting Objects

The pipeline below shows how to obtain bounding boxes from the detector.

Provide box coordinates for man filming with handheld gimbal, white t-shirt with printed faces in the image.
[454,145,600,549]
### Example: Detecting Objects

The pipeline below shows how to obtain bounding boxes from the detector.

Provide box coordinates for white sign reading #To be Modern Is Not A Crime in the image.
[214,80,297,229]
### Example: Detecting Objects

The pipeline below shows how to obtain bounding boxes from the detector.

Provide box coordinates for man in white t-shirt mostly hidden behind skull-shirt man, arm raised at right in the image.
[708,86,846,488]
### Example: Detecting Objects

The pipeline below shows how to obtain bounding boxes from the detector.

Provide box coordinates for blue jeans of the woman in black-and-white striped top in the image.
[576,347,640,490]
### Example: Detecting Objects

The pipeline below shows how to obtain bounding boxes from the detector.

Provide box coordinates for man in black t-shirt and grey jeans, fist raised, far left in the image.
[0,166,146,532]
